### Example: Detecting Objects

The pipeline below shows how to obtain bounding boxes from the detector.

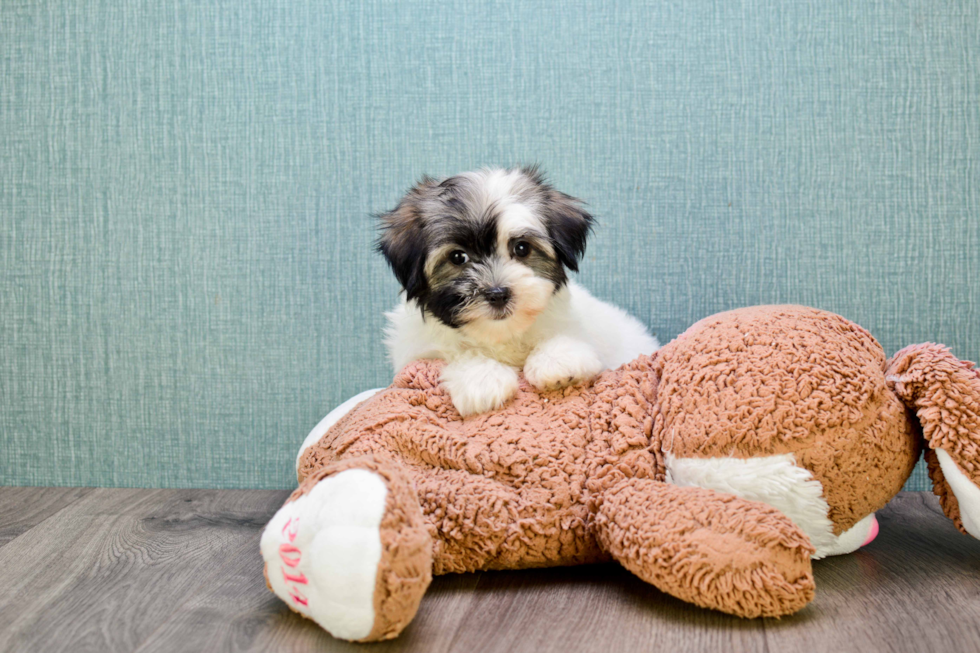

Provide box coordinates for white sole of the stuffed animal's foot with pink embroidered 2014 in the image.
[260,469,388,640]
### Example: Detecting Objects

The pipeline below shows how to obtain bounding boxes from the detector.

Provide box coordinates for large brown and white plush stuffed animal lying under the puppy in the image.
[261,306,980,641]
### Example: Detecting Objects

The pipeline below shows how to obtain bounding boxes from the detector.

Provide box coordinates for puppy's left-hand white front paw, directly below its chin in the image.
[441,356,517,417]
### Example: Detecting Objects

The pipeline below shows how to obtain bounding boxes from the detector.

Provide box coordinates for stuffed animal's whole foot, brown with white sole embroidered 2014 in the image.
[260,456,432,641]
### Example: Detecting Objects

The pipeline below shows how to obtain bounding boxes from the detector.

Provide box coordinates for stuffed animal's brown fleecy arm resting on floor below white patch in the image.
[595,479,814,617]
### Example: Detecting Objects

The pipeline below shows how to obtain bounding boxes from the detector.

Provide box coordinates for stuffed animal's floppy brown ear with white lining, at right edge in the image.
[886,343,980,539]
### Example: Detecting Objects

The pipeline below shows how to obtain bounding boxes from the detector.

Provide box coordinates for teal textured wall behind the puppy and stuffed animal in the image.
[0,0,980,487]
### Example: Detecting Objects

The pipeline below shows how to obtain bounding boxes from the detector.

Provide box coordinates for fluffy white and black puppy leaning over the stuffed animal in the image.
[378,168,659,416]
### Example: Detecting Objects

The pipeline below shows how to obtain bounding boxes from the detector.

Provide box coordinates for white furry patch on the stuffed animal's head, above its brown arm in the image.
[666,454,844,559]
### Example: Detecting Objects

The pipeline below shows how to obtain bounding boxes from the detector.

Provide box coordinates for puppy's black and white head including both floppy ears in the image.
[378,168,592,342]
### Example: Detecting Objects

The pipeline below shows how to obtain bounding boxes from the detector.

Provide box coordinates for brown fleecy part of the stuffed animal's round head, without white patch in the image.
[655,306,918,532]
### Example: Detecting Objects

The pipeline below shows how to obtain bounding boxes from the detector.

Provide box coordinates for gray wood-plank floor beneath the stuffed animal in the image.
[0,488,980,653]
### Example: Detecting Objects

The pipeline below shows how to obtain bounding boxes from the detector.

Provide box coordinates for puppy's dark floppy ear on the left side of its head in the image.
[377,177,435,299]
